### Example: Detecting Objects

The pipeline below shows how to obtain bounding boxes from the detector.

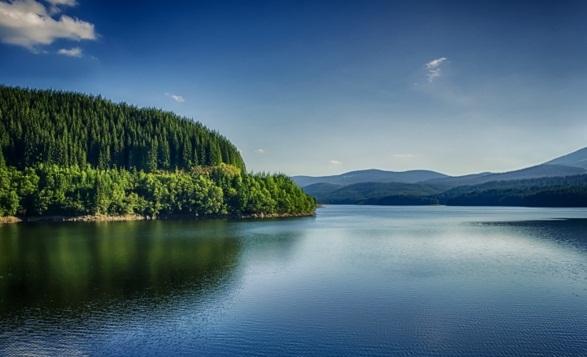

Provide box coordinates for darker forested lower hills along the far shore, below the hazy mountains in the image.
[304,175,587,207]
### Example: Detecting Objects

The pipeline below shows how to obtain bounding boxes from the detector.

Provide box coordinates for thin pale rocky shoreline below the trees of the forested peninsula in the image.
[0,212,315,224]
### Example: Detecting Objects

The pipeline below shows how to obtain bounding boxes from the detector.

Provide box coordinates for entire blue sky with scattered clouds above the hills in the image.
[0,0,587,175]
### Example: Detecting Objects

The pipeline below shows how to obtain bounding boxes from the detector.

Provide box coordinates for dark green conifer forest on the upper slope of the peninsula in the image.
[0,86,245,171]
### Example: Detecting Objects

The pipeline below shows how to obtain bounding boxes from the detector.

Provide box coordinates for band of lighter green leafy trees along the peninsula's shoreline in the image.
[0,164,316,217]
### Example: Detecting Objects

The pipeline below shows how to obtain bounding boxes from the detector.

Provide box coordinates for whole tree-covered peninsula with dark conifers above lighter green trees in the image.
[0,86,316,222]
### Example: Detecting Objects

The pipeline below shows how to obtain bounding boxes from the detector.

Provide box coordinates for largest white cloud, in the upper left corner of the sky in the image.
[0,0,96,52]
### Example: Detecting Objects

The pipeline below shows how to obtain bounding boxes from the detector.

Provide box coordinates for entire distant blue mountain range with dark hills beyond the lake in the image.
[293,148,587,206]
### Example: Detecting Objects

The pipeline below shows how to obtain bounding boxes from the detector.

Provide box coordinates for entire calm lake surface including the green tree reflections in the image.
[0,206,587,356]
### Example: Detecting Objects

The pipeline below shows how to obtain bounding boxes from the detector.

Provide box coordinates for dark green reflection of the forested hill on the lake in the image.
[0,220,241,315]
